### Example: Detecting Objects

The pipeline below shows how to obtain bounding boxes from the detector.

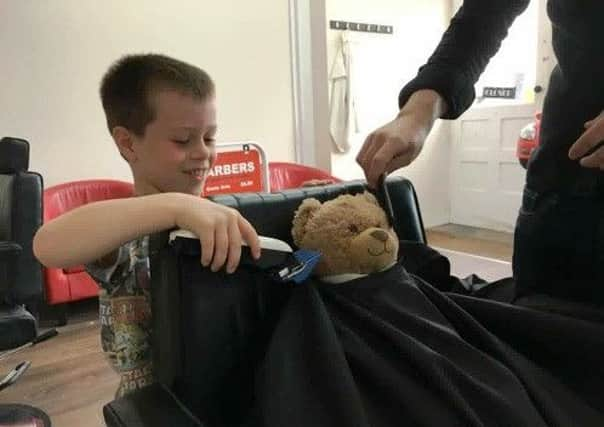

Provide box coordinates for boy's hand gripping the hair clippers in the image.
[175,195,260,273]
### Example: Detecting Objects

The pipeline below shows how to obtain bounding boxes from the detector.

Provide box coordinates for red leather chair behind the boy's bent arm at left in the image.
[44,179,134,305]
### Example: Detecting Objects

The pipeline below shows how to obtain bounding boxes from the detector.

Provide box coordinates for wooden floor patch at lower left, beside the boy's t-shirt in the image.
[0,301,119,427]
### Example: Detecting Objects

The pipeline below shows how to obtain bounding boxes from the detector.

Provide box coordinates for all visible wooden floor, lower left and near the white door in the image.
[0,225,512,427]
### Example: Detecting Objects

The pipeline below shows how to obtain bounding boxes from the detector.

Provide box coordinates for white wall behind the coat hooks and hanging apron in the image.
[326,0,451,226]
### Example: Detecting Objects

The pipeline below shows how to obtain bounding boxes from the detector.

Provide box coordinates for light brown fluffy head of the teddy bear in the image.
[292,192,398,276]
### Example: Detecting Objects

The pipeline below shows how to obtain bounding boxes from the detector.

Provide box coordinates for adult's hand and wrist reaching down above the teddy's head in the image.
[356,90,444,188]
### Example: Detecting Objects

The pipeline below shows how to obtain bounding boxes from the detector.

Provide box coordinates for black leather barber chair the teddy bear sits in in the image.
[103,177,426,427]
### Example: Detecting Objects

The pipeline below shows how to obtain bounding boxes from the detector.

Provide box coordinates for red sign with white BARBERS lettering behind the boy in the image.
[203,150,263,196]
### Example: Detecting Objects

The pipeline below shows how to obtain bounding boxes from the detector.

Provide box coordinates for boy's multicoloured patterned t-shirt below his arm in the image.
[86,237,153,397]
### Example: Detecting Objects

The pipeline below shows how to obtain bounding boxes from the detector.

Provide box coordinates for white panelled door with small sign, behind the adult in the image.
[450,0,554,231]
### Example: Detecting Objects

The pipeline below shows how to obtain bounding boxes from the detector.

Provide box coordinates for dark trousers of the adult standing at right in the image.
[513,188,604,305]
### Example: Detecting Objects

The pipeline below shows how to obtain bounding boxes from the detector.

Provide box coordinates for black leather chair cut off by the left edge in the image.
[0,137,43,351]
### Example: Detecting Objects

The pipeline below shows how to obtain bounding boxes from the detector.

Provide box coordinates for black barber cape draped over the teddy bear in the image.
[170,247,604,427]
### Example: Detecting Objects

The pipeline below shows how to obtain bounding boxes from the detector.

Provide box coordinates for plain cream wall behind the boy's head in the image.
[0,0,294,187]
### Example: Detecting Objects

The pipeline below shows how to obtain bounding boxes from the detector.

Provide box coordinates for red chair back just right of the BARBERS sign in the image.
[268,162,342,191]
